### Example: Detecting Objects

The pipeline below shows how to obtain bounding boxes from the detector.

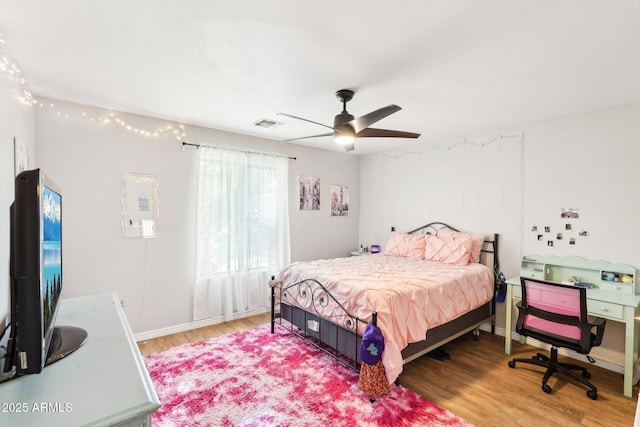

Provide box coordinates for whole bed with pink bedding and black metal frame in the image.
[269,222,500,383]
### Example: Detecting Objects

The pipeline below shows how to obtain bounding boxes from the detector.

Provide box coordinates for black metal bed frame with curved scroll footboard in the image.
[271,222,500,371]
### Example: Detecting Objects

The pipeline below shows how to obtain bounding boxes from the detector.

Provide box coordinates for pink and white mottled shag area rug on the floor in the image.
[145,325,470,427]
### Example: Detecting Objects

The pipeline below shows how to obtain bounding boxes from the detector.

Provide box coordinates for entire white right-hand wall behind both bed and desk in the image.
[359,104,640,364]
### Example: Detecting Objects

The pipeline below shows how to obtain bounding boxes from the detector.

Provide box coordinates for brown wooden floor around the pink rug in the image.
[138,314,638,427]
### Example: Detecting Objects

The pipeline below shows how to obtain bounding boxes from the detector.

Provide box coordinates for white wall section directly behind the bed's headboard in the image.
[360,131,524,275]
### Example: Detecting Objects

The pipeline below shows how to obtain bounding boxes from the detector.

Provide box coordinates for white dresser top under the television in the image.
[0,293,160,427]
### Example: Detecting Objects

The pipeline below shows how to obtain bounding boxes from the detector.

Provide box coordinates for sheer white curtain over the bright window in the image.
[194,147,290,320]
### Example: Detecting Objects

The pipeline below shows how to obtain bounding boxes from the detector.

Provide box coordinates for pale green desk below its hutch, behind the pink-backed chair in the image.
[504,277,640,397]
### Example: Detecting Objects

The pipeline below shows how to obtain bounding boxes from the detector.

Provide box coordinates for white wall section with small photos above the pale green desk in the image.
[523,104,640,268]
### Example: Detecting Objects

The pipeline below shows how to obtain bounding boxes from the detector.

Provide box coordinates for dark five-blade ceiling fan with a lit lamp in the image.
[277,89,420,151]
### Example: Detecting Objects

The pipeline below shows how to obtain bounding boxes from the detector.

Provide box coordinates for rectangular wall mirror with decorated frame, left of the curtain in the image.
[122,173,158,238]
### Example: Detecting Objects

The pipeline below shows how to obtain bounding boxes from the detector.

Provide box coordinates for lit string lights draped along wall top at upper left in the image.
[0,32,187,141]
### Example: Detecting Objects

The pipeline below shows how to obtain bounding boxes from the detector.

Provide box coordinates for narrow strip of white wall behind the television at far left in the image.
[0,71,35,327]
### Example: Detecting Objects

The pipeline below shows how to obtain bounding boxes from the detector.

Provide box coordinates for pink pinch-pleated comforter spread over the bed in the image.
[272,254,494,383]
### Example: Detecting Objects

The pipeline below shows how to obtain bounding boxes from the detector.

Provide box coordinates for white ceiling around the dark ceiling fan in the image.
[0,0,640,154]
